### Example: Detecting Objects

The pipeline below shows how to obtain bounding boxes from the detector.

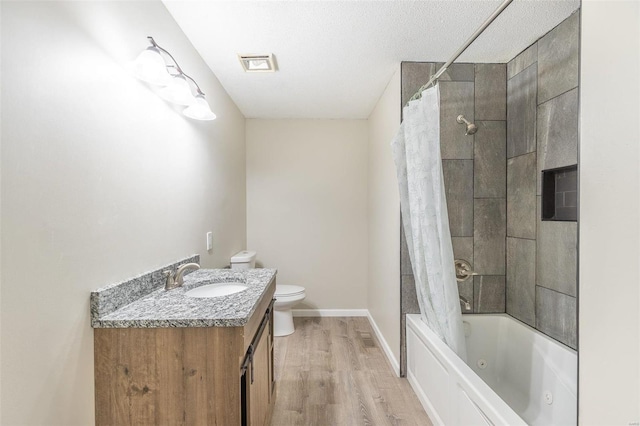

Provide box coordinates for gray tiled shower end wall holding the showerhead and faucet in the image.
[400,62,507,375]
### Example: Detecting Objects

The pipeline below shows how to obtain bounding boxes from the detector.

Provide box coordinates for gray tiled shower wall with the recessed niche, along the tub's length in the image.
[507,13,579,349]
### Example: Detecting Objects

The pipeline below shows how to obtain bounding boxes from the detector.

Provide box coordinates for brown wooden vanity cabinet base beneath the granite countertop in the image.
[94,279,275,426]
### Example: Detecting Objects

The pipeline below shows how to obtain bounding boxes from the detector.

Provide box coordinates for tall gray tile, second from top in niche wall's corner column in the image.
[507,64,538,158]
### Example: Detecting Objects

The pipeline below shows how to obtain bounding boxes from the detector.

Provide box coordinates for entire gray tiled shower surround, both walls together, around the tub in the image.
[400,13,579,375]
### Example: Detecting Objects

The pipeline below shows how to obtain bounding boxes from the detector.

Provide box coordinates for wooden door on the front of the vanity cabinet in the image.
[249,317,271,426]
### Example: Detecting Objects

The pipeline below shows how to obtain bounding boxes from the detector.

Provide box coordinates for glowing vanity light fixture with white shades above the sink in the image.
[132,37,216,120]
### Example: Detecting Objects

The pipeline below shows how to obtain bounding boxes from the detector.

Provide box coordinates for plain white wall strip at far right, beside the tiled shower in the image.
[578,0,640,425]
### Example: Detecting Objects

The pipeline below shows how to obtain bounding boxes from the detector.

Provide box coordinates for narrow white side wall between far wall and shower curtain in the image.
[367,67,401,373]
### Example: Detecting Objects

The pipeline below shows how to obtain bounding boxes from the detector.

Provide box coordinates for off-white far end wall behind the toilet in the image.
[246,119,367,309]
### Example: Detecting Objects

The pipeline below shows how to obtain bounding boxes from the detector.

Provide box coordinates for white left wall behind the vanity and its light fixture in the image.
[0,1,246,425]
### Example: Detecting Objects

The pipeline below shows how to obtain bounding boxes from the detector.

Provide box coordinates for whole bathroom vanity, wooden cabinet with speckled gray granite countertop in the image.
[92,269,276,426]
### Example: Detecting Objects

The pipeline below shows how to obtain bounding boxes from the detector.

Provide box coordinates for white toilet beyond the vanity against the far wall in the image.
[231,250,306,337]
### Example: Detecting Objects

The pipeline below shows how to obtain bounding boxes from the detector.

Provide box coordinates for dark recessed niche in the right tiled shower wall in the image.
[542,165,578,221]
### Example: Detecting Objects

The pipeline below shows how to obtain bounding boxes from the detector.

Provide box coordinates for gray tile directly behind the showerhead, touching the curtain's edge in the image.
[440,81,474,160]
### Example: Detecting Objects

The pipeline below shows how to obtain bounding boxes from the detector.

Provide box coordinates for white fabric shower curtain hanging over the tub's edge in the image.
[391,85,466,360]
